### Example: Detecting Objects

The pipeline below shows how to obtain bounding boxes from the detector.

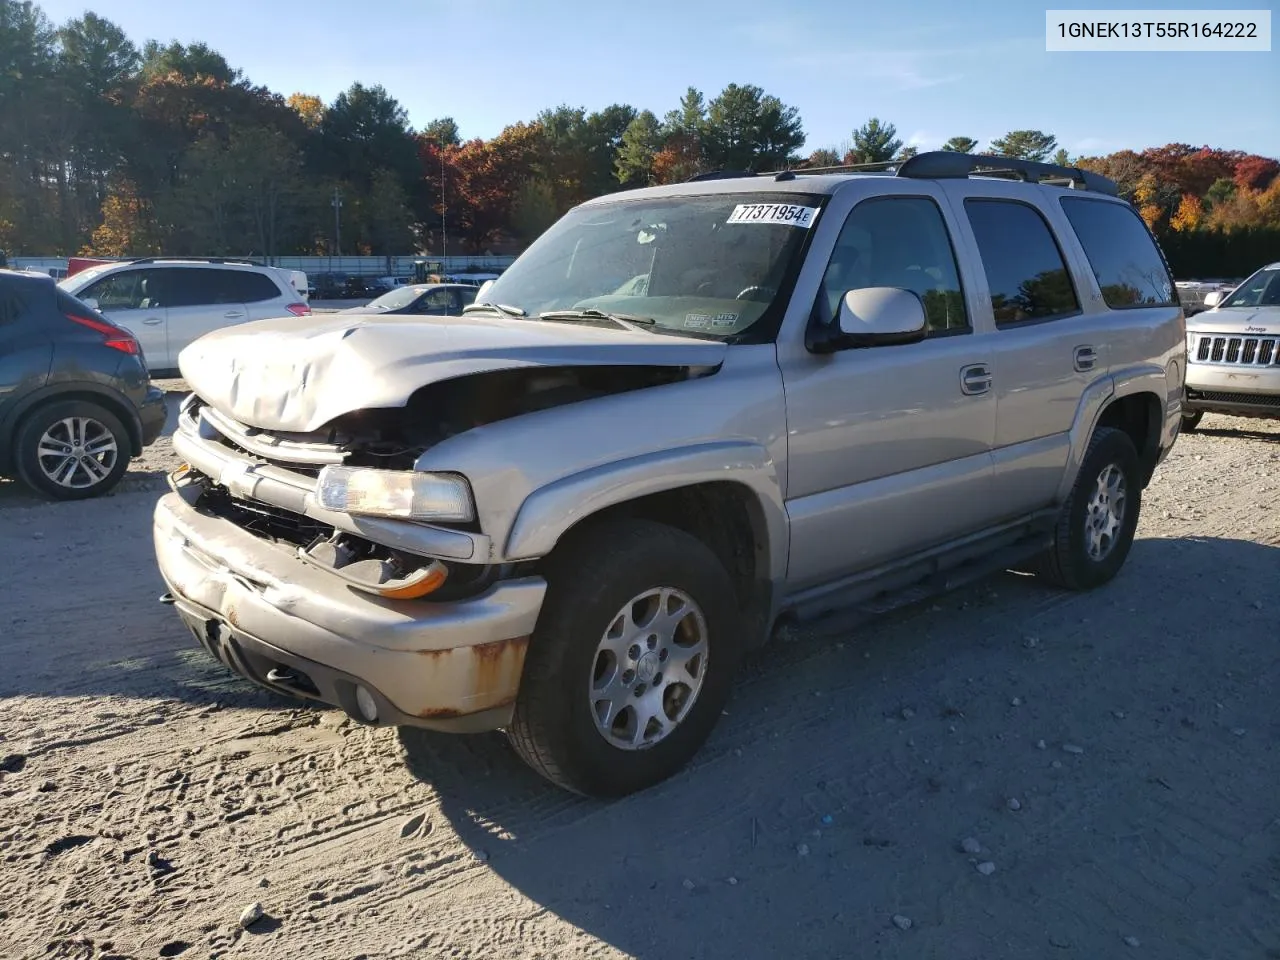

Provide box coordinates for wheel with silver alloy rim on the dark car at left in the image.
[14,401,132,500]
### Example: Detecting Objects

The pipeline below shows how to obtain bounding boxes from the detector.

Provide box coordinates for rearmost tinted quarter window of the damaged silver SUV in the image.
[1061,197,1178,310]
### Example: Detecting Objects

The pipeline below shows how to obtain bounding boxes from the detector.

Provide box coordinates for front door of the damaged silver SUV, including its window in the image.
[778,190,998,593]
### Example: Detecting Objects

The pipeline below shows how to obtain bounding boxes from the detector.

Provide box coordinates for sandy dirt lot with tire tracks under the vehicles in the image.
[0,391,1280,960]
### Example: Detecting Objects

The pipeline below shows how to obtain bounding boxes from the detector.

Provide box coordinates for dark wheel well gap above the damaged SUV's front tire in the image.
[561,481,772,645]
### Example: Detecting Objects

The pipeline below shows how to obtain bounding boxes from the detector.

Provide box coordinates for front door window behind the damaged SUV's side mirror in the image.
[819,197,969,334]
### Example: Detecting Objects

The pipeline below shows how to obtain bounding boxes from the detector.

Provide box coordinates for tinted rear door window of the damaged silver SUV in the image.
[964,198,1080,326]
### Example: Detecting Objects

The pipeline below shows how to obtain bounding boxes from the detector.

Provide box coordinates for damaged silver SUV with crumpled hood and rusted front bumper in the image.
[155,154,1185,795]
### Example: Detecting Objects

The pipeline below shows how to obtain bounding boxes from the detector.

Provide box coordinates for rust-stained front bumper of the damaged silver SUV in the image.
[154,493,547,732]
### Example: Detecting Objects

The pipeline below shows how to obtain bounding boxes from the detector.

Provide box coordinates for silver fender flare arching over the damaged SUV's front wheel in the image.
[504,440,790,582]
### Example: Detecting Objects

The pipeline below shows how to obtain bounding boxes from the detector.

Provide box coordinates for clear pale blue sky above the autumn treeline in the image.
[40,0,1280,157]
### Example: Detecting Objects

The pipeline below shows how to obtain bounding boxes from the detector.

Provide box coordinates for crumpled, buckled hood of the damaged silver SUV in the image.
[178,314,727,433]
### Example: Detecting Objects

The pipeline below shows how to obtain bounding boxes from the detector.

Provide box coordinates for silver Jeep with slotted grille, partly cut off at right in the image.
[1183,264,1280,430]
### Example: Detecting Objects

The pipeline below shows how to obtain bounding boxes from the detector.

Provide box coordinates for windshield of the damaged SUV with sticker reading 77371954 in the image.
[476,193,823,338]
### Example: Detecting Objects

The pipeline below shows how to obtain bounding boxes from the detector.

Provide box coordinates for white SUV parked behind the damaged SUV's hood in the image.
[59,257,311,371]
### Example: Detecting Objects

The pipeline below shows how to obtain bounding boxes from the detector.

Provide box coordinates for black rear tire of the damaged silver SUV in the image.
[1036,426,1142,590]
